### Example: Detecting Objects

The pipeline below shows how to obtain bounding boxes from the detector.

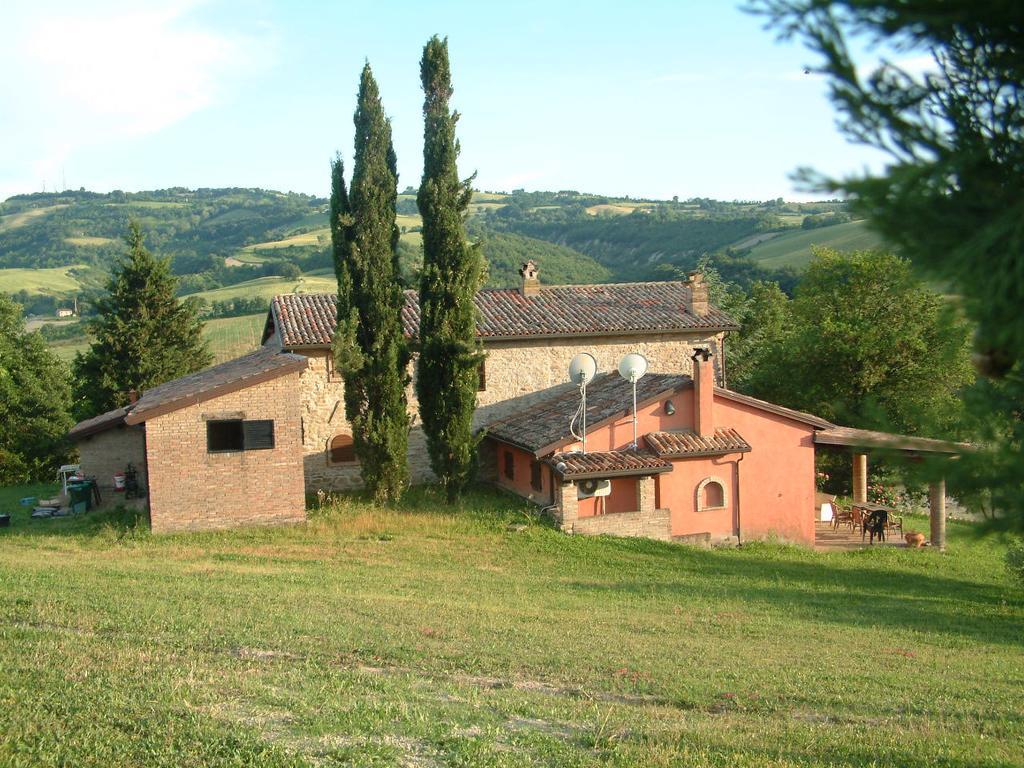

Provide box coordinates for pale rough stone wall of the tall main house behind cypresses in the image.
[284,332,724,494]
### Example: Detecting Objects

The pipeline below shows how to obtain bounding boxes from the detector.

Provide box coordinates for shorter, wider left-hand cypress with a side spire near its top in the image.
[331,63,409,503]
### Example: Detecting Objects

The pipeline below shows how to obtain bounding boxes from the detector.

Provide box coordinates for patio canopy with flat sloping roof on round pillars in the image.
[814,427,971,550]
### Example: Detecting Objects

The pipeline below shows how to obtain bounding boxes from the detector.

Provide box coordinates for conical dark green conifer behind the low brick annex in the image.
[74,221,212,418]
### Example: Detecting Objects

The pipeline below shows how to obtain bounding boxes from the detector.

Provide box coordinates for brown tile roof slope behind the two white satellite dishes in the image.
[484,374,692,456]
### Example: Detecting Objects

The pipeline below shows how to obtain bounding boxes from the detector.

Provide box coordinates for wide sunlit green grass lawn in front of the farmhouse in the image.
[0,488,1024,768]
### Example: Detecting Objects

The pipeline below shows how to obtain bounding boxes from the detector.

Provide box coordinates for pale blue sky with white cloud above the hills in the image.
[0,0,897,200]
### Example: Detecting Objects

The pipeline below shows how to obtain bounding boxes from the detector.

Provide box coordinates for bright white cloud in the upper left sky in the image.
[0,0,271,200]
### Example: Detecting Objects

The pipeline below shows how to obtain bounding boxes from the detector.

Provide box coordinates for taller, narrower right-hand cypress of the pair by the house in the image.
[416,35,483,502]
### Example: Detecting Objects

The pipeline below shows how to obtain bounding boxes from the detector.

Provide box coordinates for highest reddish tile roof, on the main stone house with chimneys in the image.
[264,283,736,348]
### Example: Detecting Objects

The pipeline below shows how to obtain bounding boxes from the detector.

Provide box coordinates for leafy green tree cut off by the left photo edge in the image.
[0,294,73,485]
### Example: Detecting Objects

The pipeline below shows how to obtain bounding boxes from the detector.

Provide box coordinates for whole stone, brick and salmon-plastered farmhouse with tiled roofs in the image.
[70,262,950,544]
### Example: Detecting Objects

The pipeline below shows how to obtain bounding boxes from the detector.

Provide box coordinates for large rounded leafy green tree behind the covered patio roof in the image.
[743,249,974,434]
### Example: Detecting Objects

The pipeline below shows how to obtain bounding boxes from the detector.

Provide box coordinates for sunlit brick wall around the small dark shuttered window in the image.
[145,373,306,532]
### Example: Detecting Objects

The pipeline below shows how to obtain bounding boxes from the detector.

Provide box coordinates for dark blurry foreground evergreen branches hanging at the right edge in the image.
[752,0,1024,529]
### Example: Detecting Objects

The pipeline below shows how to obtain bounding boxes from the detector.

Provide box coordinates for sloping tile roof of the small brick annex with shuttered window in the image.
[125,347,307,424]
